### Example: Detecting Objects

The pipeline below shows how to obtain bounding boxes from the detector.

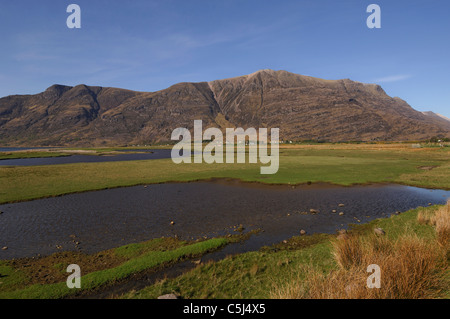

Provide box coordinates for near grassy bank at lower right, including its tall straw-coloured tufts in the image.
[123,202,450,298]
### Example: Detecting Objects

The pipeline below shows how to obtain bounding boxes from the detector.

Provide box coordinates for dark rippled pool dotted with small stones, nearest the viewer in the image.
[0,180,450,259]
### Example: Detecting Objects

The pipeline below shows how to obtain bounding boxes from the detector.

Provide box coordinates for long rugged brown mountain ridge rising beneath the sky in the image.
[0,70,450,146]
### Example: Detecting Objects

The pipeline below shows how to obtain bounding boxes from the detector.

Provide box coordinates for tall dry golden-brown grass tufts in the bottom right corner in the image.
[272,230,447,299]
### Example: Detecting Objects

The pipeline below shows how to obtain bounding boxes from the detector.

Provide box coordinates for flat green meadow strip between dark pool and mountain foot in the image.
[0,144,450,203]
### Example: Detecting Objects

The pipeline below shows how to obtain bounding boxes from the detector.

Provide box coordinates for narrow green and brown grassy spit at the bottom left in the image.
[0,238,228,299]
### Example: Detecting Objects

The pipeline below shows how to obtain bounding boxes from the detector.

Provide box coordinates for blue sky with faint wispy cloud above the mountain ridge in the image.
[0,0,450,117]
